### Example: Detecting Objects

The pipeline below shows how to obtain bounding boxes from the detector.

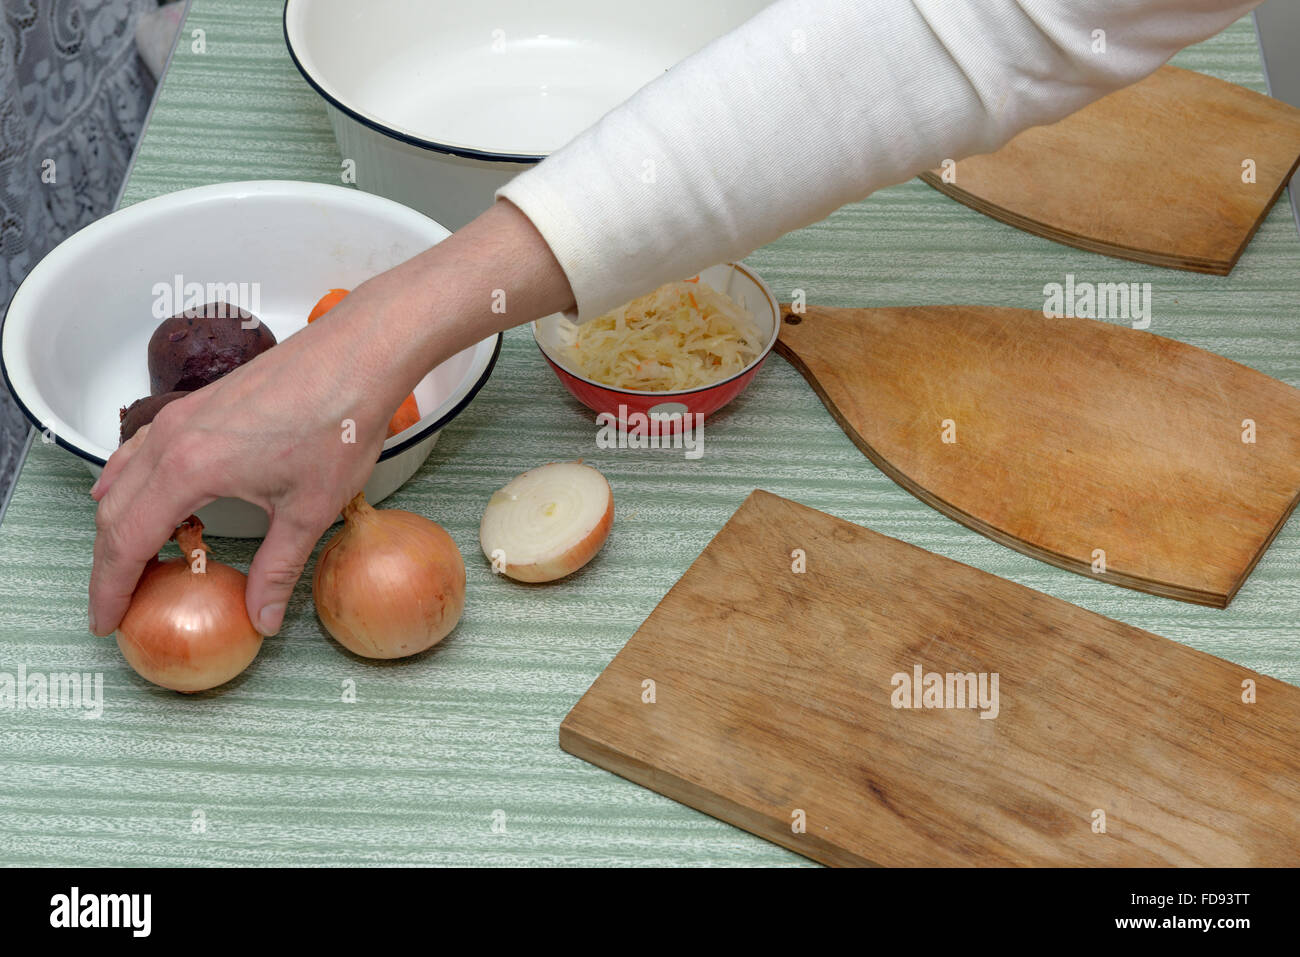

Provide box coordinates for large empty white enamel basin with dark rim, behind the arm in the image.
[285,0,770,229]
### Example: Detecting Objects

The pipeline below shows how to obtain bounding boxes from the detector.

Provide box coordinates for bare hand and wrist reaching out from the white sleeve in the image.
[90,202,573,635]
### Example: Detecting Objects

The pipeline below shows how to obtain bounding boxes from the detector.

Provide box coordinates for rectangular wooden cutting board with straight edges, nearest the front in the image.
[560,492,1300,866]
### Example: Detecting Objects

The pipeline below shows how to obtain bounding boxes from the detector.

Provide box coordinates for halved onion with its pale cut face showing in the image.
[478,462,614,581]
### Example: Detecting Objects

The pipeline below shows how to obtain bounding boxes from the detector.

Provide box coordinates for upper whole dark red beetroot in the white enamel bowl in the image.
[150,303,276,397]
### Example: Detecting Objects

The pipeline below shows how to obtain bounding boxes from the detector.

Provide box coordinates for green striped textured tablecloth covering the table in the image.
[0,0,1300,865]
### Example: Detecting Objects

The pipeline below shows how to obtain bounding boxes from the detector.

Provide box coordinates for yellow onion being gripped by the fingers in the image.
[117,515,261,693]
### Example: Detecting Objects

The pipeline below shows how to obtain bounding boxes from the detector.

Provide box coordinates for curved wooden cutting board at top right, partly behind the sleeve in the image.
[920,66,1300,276]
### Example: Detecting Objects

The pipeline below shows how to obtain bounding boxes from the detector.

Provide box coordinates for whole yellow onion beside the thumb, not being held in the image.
[312,493,465,658]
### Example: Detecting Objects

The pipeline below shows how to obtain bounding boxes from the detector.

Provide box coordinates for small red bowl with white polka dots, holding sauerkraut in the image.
[533,263,781,432]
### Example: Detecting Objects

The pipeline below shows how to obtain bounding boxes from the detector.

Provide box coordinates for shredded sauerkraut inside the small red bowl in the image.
[563,280,766,393]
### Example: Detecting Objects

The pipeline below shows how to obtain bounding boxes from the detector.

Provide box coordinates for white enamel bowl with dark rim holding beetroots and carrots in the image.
[0,181,501,538]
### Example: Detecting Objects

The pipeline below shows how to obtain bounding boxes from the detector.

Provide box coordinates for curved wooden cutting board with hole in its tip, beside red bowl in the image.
[776,306,1300,609]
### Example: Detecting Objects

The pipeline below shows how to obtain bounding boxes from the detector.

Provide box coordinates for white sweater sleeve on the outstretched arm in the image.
[497,0,1260,321]
